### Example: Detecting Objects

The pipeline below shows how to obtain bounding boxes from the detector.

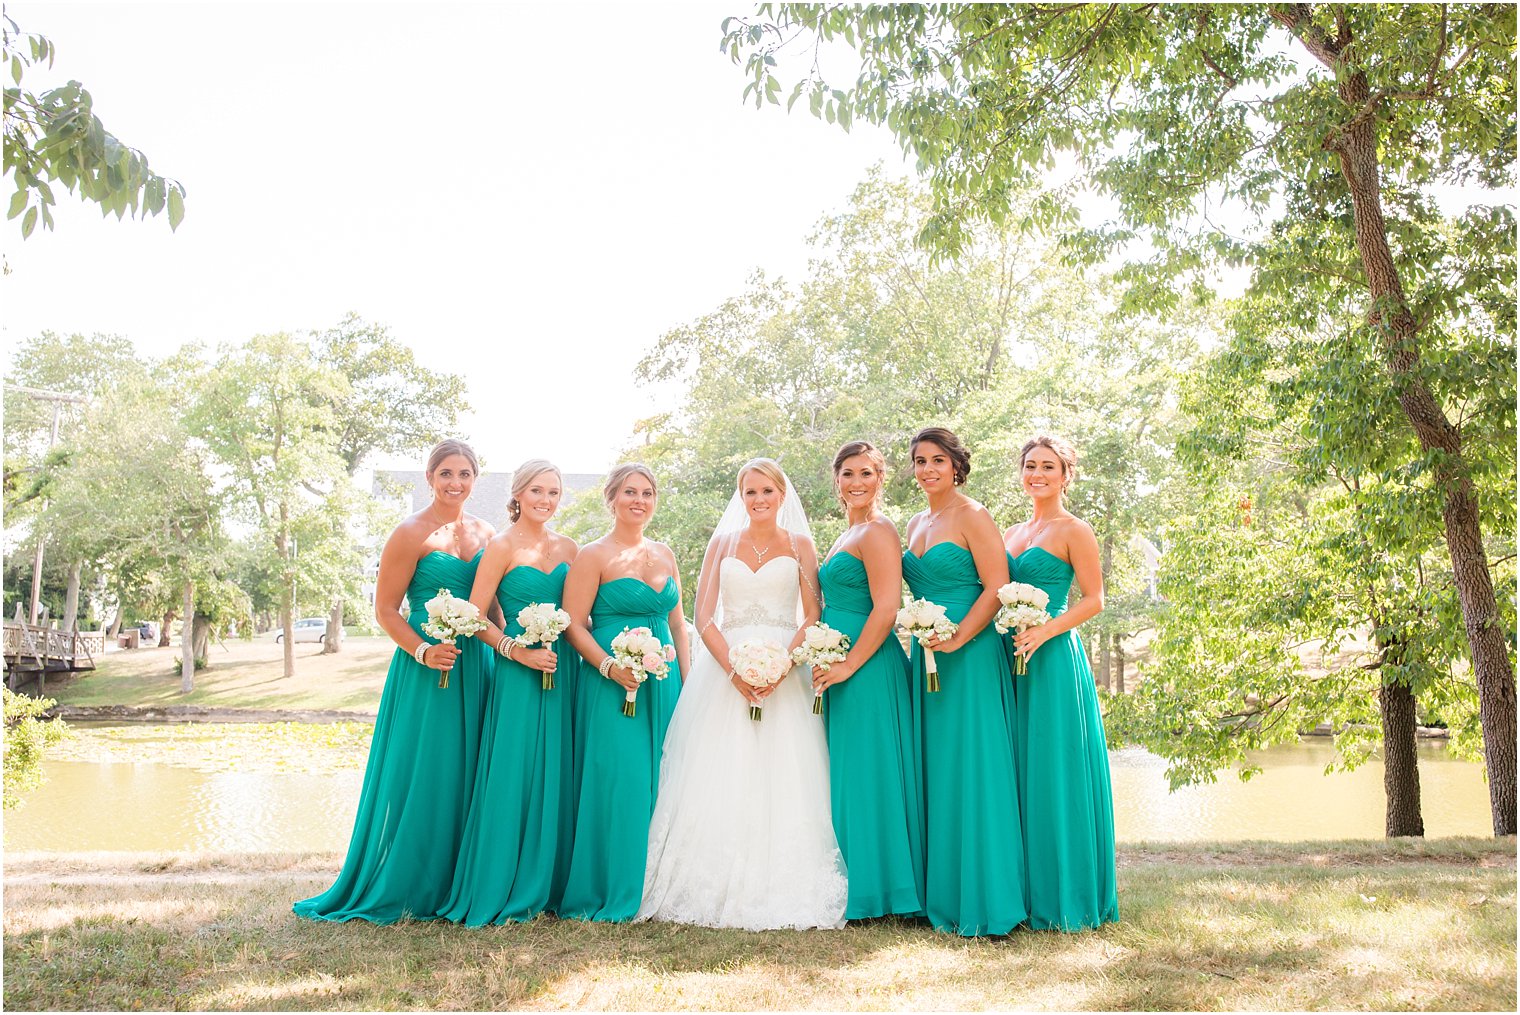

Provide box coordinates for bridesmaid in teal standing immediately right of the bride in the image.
[813,441,924,919]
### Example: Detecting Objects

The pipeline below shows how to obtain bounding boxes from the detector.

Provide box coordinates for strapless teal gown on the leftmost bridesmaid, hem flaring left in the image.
[292,550,491,924]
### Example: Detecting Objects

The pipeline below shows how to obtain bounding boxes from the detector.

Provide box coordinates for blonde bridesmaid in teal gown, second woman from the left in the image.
[438,459,576,927]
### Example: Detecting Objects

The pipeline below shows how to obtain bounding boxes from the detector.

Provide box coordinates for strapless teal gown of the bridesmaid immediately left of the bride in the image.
[558,577,681,921]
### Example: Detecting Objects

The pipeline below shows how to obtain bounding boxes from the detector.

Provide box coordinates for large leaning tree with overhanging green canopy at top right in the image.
[724,3,1515,834]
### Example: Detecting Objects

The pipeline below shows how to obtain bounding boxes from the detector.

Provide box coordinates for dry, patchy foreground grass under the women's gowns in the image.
[5,839,1515,1010]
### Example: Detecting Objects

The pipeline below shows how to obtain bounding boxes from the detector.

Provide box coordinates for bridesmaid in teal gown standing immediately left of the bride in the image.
[558,463,690,921]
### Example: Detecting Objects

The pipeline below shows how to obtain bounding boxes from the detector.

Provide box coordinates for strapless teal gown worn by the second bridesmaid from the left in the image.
[438,564,576,927]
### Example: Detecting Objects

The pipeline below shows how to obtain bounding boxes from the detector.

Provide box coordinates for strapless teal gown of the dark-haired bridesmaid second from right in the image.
[903,542,1029,938]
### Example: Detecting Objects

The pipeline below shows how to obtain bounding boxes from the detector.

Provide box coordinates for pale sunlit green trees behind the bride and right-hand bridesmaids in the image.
[623,173,1202,622]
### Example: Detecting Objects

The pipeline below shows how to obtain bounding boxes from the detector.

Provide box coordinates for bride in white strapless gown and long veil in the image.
[638,459,847,930]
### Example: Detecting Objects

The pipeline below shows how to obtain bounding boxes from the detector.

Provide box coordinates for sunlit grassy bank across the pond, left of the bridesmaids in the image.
[47,635,395,711]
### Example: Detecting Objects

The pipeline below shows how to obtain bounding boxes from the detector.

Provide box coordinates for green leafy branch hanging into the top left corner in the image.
[3,15,185,239]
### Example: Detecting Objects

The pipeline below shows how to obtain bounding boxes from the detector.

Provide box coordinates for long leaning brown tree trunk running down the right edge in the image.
[1271,13,1515,836]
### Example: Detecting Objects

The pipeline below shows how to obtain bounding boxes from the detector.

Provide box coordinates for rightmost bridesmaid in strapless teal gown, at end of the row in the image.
[1003,435,1119,930]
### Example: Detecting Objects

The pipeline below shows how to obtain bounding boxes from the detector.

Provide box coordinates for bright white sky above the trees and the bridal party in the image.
[0,2,906,473]
